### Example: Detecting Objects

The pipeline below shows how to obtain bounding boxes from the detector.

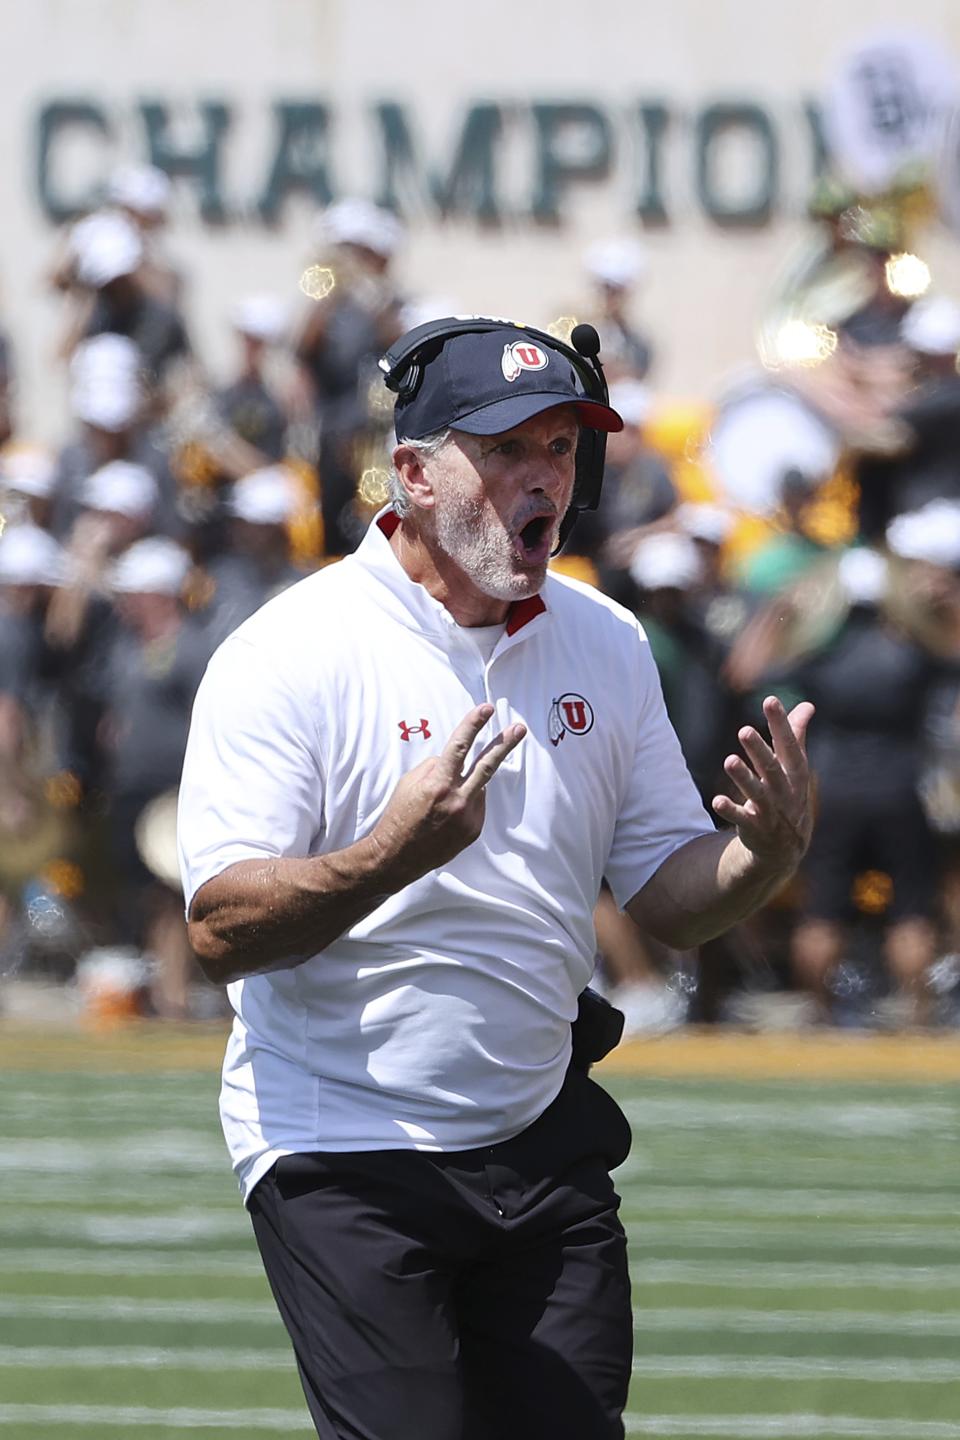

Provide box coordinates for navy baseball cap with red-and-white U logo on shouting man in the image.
[394,324,623,441]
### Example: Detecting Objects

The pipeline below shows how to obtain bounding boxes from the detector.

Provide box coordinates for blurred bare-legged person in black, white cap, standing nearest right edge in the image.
[735,524,960,1022]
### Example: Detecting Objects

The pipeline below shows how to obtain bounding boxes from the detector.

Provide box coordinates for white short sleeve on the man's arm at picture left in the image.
[177,636,324,909]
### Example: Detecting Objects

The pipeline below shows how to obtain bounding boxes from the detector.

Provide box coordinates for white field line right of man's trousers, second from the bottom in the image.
[630,1351,960,1385]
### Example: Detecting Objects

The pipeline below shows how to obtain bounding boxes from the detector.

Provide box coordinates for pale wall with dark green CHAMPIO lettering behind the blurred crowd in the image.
[0,0,960,435]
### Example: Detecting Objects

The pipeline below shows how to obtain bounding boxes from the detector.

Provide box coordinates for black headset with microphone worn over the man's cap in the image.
[380,315,610,554]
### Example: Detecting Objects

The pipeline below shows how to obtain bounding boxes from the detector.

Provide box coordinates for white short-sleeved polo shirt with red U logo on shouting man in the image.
[180,511,712,1195]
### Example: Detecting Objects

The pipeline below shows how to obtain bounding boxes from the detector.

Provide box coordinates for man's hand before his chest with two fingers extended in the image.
[371,704,527,884]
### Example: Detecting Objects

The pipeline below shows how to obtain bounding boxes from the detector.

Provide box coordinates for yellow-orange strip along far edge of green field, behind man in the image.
[0,1020,960,1083]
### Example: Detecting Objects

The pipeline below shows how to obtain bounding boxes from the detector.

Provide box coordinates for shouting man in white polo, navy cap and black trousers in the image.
[180,323,812,1440]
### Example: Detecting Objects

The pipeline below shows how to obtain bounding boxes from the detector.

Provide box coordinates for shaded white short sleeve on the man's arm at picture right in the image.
[604,626,714,909]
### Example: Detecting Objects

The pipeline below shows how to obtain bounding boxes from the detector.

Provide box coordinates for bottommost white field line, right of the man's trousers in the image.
[623,1414,960,1440]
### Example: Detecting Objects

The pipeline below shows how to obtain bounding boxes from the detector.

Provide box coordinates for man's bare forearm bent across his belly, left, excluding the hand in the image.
[189,835,409,985]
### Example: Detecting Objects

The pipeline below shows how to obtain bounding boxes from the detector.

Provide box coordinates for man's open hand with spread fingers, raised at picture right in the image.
[712,696,813,873]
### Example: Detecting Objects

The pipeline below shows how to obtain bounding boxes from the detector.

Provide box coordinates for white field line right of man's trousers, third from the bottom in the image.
[633,1305,960,1338]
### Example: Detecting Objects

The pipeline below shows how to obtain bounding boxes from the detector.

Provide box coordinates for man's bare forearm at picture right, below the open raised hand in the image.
[626,831,794,949]
